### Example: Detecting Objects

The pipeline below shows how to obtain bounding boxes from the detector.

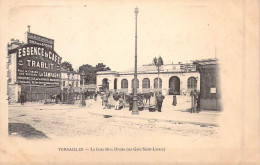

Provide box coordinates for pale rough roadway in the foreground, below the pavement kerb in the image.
[8,99,219,138]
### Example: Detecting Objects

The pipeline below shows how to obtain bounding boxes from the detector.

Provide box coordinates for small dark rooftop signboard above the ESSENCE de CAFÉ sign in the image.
[27,32,54,50]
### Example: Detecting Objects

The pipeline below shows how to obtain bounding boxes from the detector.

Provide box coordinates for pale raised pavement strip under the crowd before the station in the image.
[9,96,221,127]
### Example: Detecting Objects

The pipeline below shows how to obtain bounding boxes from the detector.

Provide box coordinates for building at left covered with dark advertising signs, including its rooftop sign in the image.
[7,31,61,103]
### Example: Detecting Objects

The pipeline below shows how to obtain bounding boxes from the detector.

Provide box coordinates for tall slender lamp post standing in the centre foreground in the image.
[132,7,139,115]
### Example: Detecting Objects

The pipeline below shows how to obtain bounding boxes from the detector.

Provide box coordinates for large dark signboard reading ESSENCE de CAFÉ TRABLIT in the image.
[16,44,61,86]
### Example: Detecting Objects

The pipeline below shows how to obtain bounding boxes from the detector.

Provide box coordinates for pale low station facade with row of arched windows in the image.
[96,63,200,95]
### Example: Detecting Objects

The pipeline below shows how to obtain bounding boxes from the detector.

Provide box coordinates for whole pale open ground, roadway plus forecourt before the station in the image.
[8,97,219,139]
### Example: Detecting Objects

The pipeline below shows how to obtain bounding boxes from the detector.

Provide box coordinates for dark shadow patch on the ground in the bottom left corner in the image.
[8,123,48,139]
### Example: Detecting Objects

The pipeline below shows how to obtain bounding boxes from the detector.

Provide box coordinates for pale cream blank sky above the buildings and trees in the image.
[3,0,232,71]
